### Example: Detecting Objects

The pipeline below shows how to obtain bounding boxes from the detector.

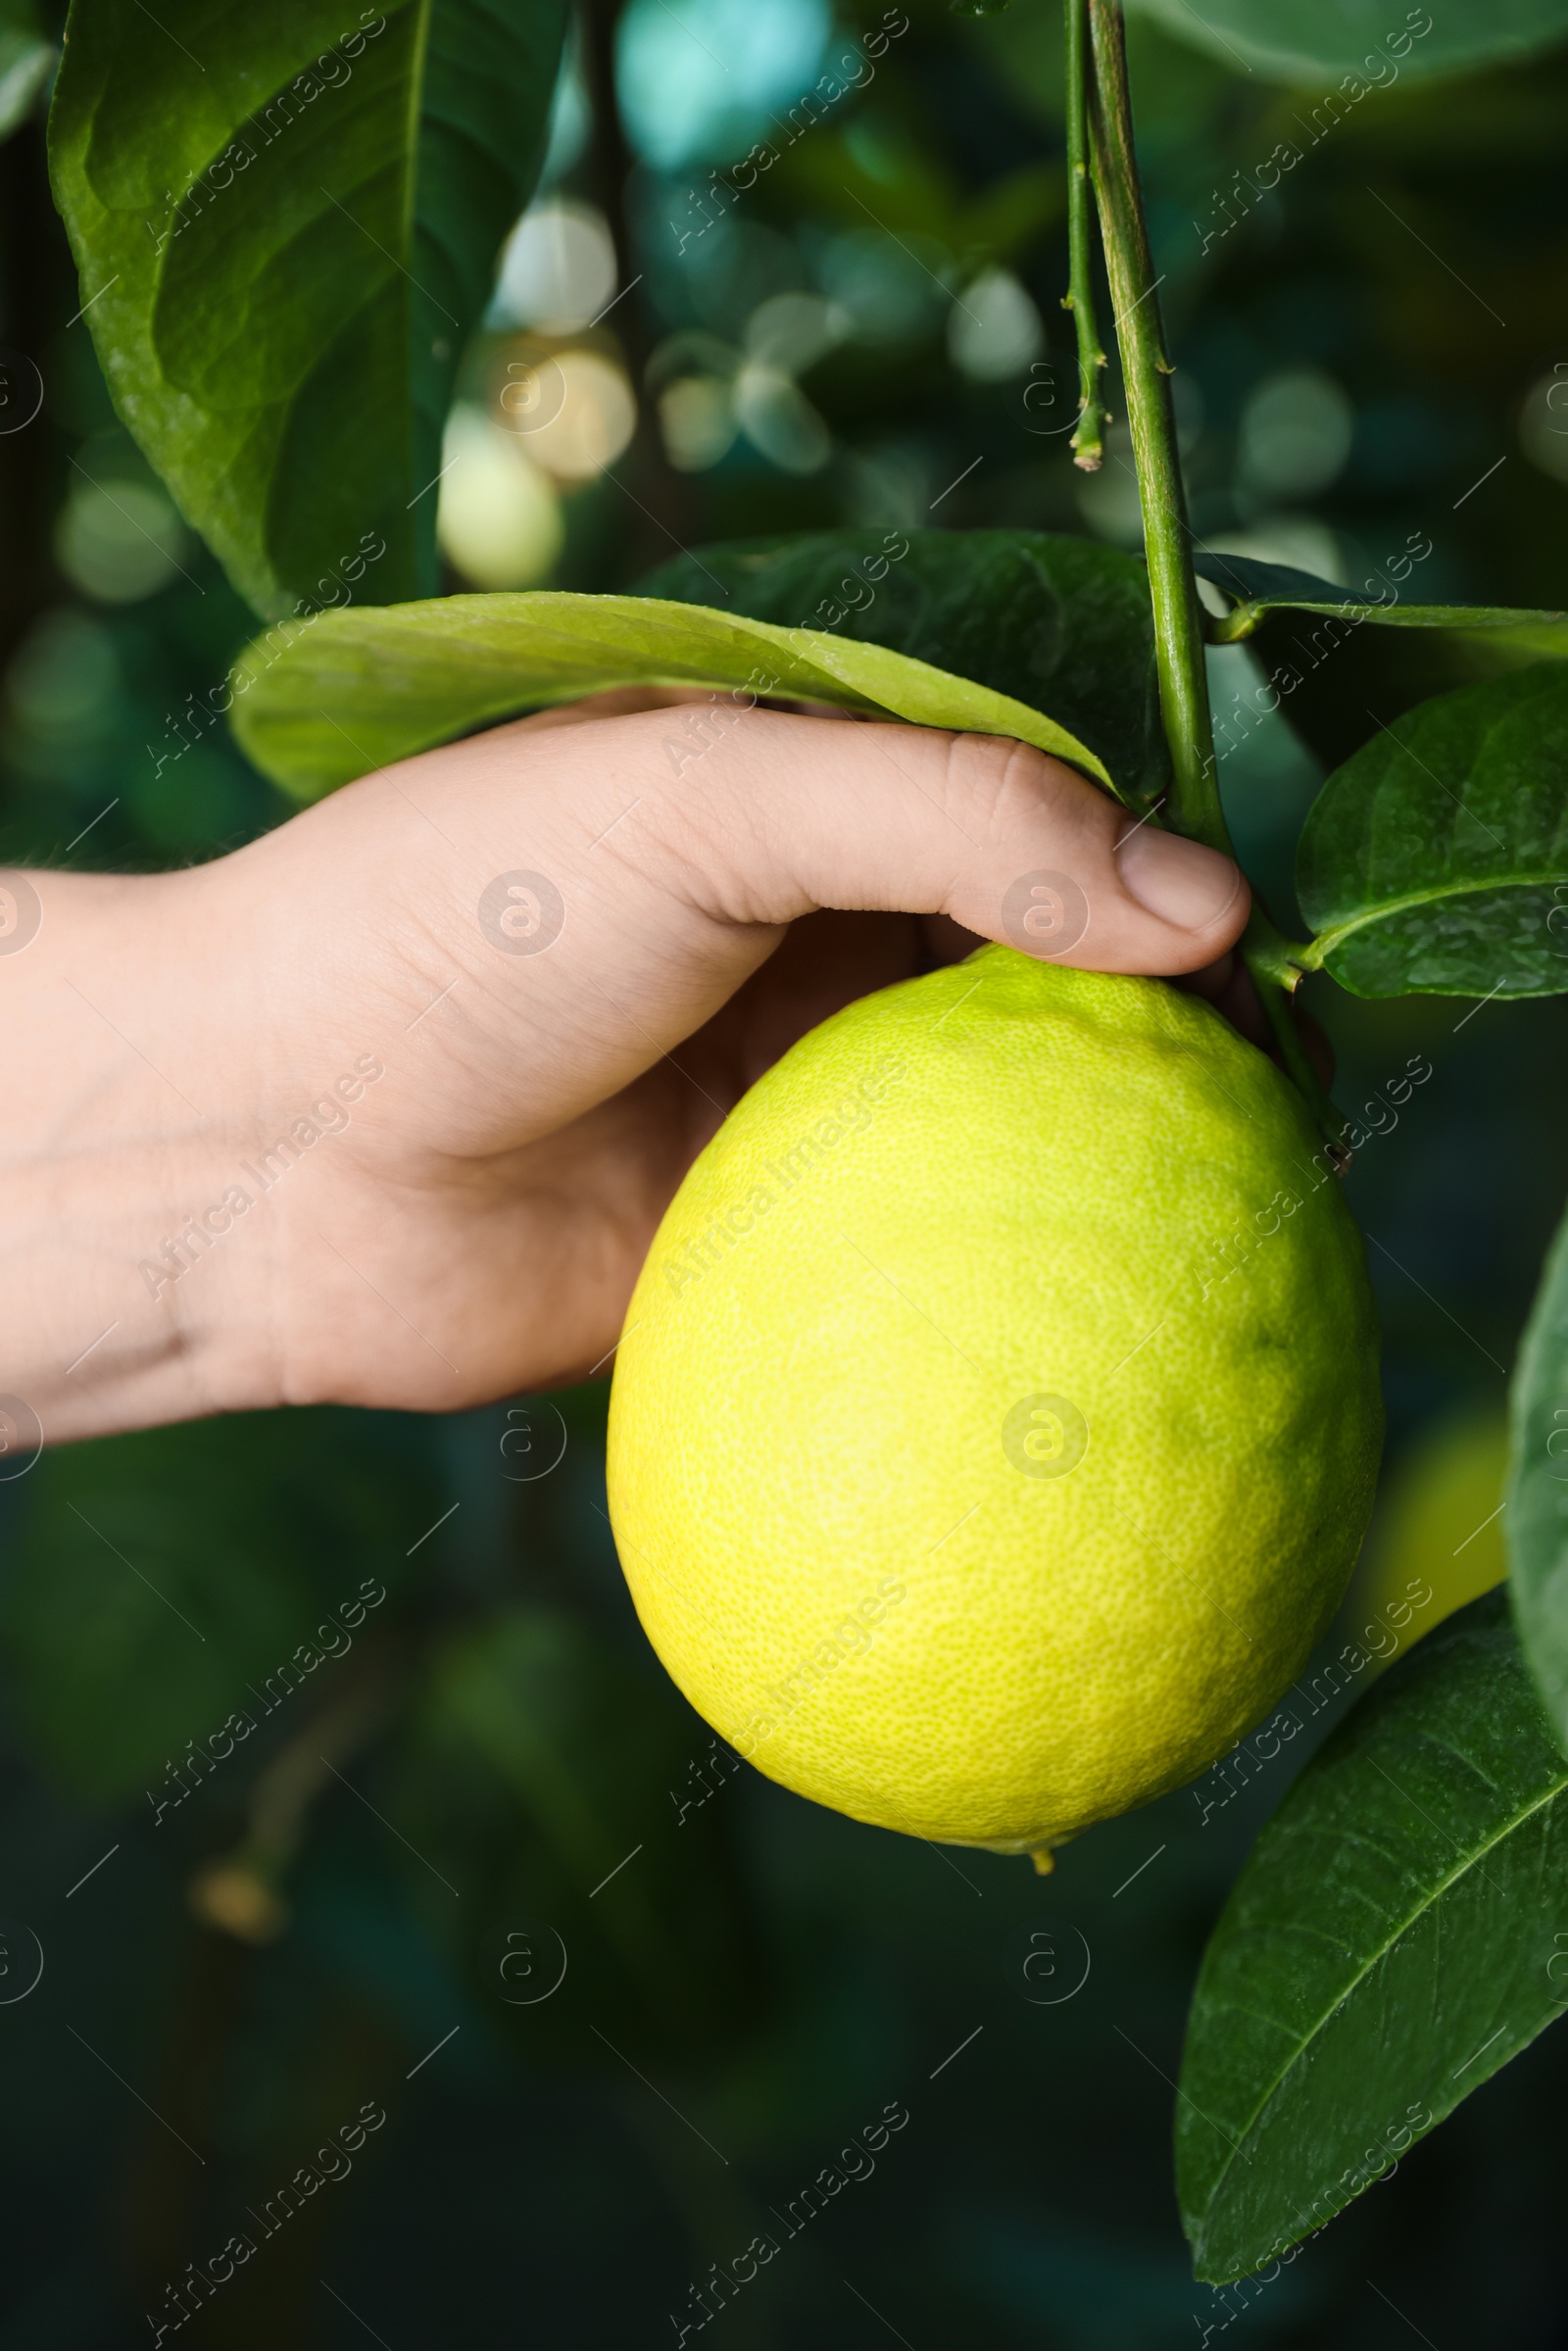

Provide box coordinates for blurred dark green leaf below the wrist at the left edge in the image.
[0,1410,440,1803]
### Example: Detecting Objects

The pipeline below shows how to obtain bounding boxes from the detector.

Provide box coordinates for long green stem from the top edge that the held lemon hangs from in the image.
[1067,0,1345,1152]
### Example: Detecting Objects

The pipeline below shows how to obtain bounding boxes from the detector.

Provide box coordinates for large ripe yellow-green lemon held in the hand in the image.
[609,948,1382,1867]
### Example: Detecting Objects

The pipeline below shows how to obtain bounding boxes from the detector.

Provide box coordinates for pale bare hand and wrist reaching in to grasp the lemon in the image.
[0,694,1255,1445]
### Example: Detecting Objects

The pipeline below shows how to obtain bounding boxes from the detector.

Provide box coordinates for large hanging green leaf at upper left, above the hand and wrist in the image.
[49,0,575,613]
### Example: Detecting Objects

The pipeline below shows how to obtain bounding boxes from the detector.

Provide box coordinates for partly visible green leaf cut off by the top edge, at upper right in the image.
[1136,0,1568,84]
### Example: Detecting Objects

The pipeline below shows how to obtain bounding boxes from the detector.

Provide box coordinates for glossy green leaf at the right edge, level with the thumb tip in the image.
[1296,663,1568,997]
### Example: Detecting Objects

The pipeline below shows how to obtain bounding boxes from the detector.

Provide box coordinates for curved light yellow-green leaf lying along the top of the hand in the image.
[232,590,1112,800]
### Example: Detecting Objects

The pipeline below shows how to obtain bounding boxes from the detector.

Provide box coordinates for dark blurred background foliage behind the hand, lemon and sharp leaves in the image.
[0,0,1568,2351]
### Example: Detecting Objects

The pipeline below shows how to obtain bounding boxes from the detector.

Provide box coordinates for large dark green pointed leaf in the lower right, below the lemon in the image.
[1175,1592,1568,2285]
